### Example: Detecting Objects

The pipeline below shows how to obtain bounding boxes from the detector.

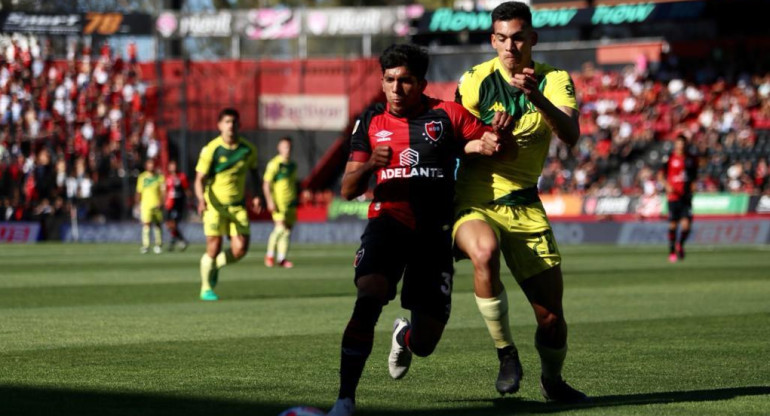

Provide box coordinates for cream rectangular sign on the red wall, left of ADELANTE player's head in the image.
[259,94,349,131]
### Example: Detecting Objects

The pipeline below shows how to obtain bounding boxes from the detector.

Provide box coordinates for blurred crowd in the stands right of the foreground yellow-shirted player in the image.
[540,59,770,196]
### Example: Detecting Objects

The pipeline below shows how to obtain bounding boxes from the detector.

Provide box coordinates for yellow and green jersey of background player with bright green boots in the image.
[195,136,257,206]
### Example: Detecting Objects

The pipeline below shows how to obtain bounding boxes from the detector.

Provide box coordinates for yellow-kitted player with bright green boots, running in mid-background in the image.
[195,108,262,301]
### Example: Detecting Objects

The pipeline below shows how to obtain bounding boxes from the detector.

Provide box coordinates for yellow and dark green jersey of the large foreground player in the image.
[456,57,577,202]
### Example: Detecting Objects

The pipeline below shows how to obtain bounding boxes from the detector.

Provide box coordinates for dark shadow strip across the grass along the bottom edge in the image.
[0,386,770,416]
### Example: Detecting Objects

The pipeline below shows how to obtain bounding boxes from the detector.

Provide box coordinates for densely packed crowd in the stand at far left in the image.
[0,37,154,237]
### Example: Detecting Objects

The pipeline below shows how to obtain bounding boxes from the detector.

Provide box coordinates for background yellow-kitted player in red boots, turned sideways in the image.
[262,137,297,268]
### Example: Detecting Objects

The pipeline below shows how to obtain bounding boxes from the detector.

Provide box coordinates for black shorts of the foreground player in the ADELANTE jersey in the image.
[353,216,454,323]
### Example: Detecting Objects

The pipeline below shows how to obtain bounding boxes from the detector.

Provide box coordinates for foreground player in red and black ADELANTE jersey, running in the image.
[329,45,499,416]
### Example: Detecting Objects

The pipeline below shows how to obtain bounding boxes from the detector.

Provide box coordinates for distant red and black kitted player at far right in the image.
[665,134,698,263]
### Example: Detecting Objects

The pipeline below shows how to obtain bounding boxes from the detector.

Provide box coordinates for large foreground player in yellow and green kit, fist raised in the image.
[454,2,586,403]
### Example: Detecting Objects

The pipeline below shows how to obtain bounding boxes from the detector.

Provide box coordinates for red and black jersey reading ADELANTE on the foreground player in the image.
[349,96,489,228]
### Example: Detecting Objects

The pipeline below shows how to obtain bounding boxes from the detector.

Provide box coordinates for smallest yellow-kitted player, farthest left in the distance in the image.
[136,159,166,254]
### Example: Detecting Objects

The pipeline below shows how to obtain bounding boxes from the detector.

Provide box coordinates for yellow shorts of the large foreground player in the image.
[452,202,561,283]
